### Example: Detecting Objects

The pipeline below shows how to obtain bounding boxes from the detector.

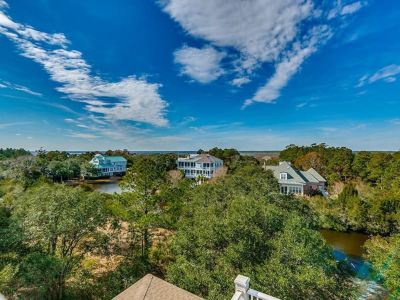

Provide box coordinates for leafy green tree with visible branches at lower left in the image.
[11,185,107,299]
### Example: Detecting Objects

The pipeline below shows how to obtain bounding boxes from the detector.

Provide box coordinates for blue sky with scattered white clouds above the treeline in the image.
[0,0,400,150]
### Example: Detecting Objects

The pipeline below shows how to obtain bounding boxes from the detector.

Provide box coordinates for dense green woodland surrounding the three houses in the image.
[0,144,400,299]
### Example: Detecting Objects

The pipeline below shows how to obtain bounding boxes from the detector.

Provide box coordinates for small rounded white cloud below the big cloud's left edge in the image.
[174,46,225,83]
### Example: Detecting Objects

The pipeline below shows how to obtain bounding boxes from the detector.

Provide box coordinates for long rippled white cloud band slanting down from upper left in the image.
[0,0,168,126]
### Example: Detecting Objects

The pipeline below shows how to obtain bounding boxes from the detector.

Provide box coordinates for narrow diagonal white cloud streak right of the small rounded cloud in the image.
[243,26,332,107]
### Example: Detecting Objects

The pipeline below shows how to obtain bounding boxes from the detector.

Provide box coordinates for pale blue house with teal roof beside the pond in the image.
[90,154,127,176]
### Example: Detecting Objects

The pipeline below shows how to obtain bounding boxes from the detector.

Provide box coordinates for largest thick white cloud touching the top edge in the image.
[162,0,313,69]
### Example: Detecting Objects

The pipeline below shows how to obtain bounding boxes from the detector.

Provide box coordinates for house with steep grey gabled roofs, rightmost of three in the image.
[264,161,327,196]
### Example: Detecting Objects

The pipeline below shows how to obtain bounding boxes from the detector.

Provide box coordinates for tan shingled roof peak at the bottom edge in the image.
[113,274,203,300]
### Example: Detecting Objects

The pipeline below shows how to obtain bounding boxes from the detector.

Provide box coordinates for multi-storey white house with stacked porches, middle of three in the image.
[176,154,224,179]
